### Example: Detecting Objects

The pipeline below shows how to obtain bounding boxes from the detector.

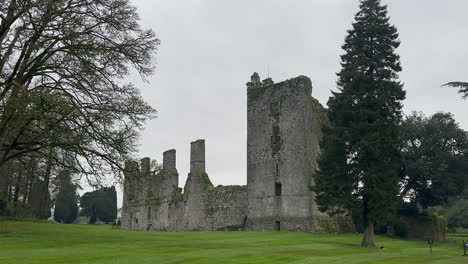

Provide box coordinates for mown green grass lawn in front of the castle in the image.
[0,221,468,264]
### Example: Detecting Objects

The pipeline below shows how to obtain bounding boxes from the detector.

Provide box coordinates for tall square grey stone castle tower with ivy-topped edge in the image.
[247,73,325,231]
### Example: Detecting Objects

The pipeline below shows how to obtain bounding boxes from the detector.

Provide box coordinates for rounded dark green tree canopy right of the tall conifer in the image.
[401,112,468,208]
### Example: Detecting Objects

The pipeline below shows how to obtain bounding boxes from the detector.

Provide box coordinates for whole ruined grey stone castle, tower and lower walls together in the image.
[122,73,350,232]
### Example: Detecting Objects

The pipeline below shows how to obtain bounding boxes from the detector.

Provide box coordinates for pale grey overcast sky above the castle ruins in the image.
[111,0,468,206]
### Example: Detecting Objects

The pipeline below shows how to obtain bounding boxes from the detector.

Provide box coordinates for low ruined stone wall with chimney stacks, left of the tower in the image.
[122,140,247,231]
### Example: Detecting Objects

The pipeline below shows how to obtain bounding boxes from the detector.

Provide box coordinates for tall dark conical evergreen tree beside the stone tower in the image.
[315,0,406,247]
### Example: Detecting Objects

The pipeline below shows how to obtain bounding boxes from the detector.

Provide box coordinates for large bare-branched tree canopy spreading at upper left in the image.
[0,0,159,184]
